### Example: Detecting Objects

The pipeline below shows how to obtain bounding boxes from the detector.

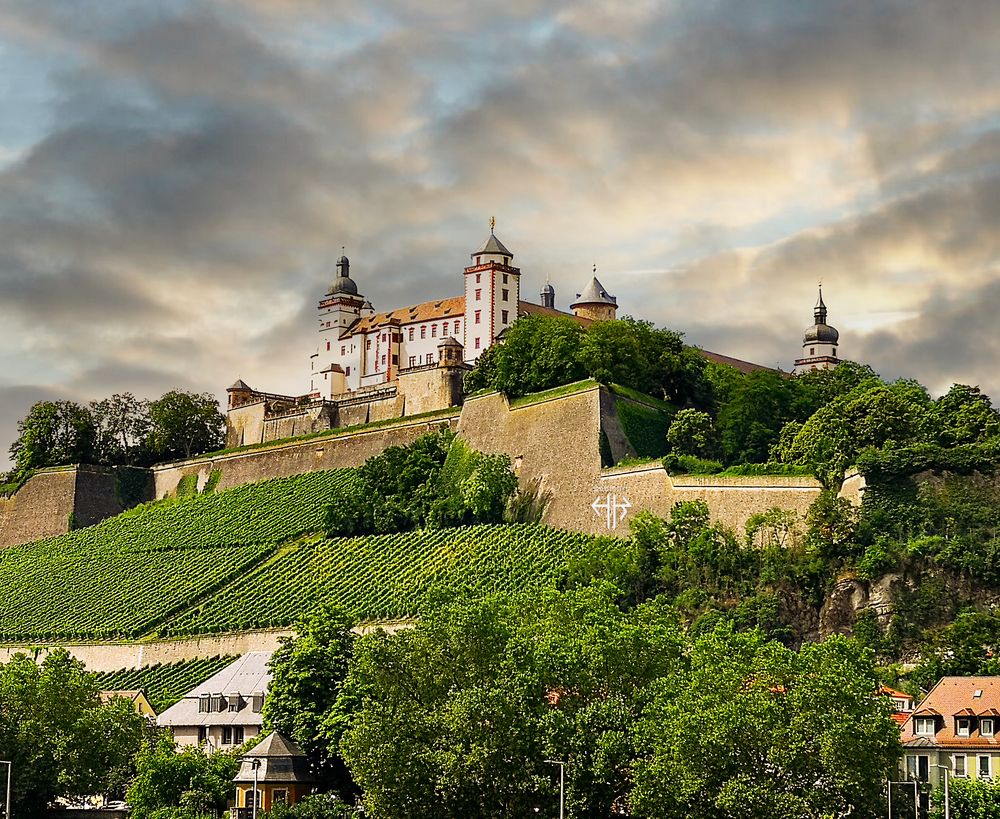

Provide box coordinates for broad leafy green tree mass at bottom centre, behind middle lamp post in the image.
[341,585,682,818]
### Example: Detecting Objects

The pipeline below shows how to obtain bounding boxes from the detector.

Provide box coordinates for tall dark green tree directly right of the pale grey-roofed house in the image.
[264,605,354,792]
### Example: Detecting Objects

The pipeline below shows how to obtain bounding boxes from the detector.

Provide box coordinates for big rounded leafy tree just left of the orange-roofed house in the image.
[631,627,901,819]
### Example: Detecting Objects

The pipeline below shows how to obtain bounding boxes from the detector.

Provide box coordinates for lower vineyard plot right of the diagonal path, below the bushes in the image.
[163,524,592,635]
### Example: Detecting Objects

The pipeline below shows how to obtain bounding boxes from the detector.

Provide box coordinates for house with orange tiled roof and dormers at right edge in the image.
[900,677,1000,809]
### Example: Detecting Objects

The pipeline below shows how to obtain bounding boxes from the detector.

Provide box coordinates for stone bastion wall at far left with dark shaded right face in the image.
[0,466,132,548]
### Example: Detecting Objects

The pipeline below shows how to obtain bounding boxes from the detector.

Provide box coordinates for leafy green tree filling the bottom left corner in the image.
[0,649,146,816]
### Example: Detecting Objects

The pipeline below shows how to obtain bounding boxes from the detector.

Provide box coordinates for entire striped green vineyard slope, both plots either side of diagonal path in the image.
[0,470,589,642]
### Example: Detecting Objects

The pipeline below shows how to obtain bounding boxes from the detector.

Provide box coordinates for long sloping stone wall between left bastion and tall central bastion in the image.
[153,408,459,498]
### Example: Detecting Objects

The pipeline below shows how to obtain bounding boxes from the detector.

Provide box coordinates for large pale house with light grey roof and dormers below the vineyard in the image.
[157,651,271,749]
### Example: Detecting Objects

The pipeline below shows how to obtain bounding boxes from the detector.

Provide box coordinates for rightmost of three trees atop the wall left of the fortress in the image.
[149,390,226,458]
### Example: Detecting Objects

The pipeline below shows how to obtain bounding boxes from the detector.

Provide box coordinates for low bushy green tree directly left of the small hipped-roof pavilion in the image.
[126,733,239,819]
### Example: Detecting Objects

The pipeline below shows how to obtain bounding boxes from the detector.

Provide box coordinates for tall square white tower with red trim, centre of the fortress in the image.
[462,217,521,362]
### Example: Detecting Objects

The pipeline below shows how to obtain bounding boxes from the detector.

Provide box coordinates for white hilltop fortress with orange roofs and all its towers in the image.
[226,224,840,447]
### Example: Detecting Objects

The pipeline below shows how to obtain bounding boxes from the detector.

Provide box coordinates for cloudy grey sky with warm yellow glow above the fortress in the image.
[0,0,1000,469]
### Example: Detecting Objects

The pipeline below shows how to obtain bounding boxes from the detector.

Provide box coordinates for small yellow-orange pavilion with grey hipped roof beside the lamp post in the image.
[233,731,315,819]
